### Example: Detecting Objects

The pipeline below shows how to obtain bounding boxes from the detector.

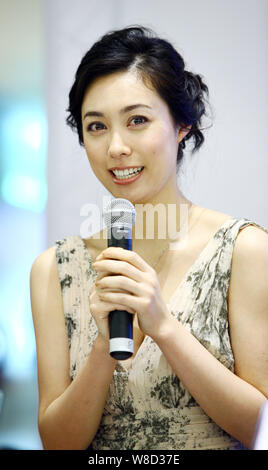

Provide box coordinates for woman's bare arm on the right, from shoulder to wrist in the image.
[154,227,268,448]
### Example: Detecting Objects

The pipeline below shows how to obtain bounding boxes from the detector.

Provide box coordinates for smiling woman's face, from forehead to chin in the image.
[81,72,185,203]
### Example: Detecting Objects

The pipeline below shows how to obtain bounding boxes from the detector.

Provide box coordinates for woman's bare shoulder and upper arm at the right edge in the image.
[228,225,268,396]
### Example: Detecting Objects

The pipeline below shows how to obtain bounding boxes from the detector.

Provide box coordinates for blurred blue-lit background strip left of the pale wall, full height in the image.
[0,0,47,449]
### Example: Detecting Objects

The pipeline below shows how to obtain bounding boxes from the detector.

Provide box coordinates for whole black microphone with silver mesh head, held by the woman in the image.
[104,198,136,360]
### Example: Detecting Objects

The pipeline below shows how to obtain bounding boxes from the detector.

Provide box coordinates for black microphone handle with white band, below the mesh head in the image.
[108,226,134,361]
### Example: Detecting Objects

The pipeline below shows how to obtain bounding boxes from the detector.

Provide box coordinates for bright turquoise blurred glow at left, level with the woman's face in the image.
[0,99,47,213]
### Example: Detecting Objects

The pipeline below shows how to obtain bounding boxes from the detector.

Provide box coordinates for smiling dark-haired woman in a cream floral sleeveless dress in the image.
[31,27,268,449]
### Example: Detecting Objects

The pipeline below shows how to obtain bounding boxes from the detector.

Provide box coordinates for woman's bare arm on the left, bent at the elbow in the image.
[30,247,116,449]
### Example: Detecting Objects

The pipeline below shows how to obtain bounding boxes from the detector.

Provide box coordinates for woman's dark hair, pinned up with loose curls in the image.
[66,25,209,169]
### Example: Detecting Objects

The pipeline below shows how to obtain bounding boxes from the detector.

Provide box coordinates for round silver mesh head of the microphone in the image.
[103,198,136,229]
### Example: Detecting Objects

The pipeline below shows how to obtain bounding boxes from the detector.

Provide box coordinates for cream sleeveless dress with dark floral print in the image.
[55,218,268,450]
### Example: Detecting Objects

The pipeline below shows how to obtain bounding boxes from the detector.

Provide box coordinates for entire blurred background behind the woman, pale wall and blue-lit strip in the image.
[0,0,268,449]
